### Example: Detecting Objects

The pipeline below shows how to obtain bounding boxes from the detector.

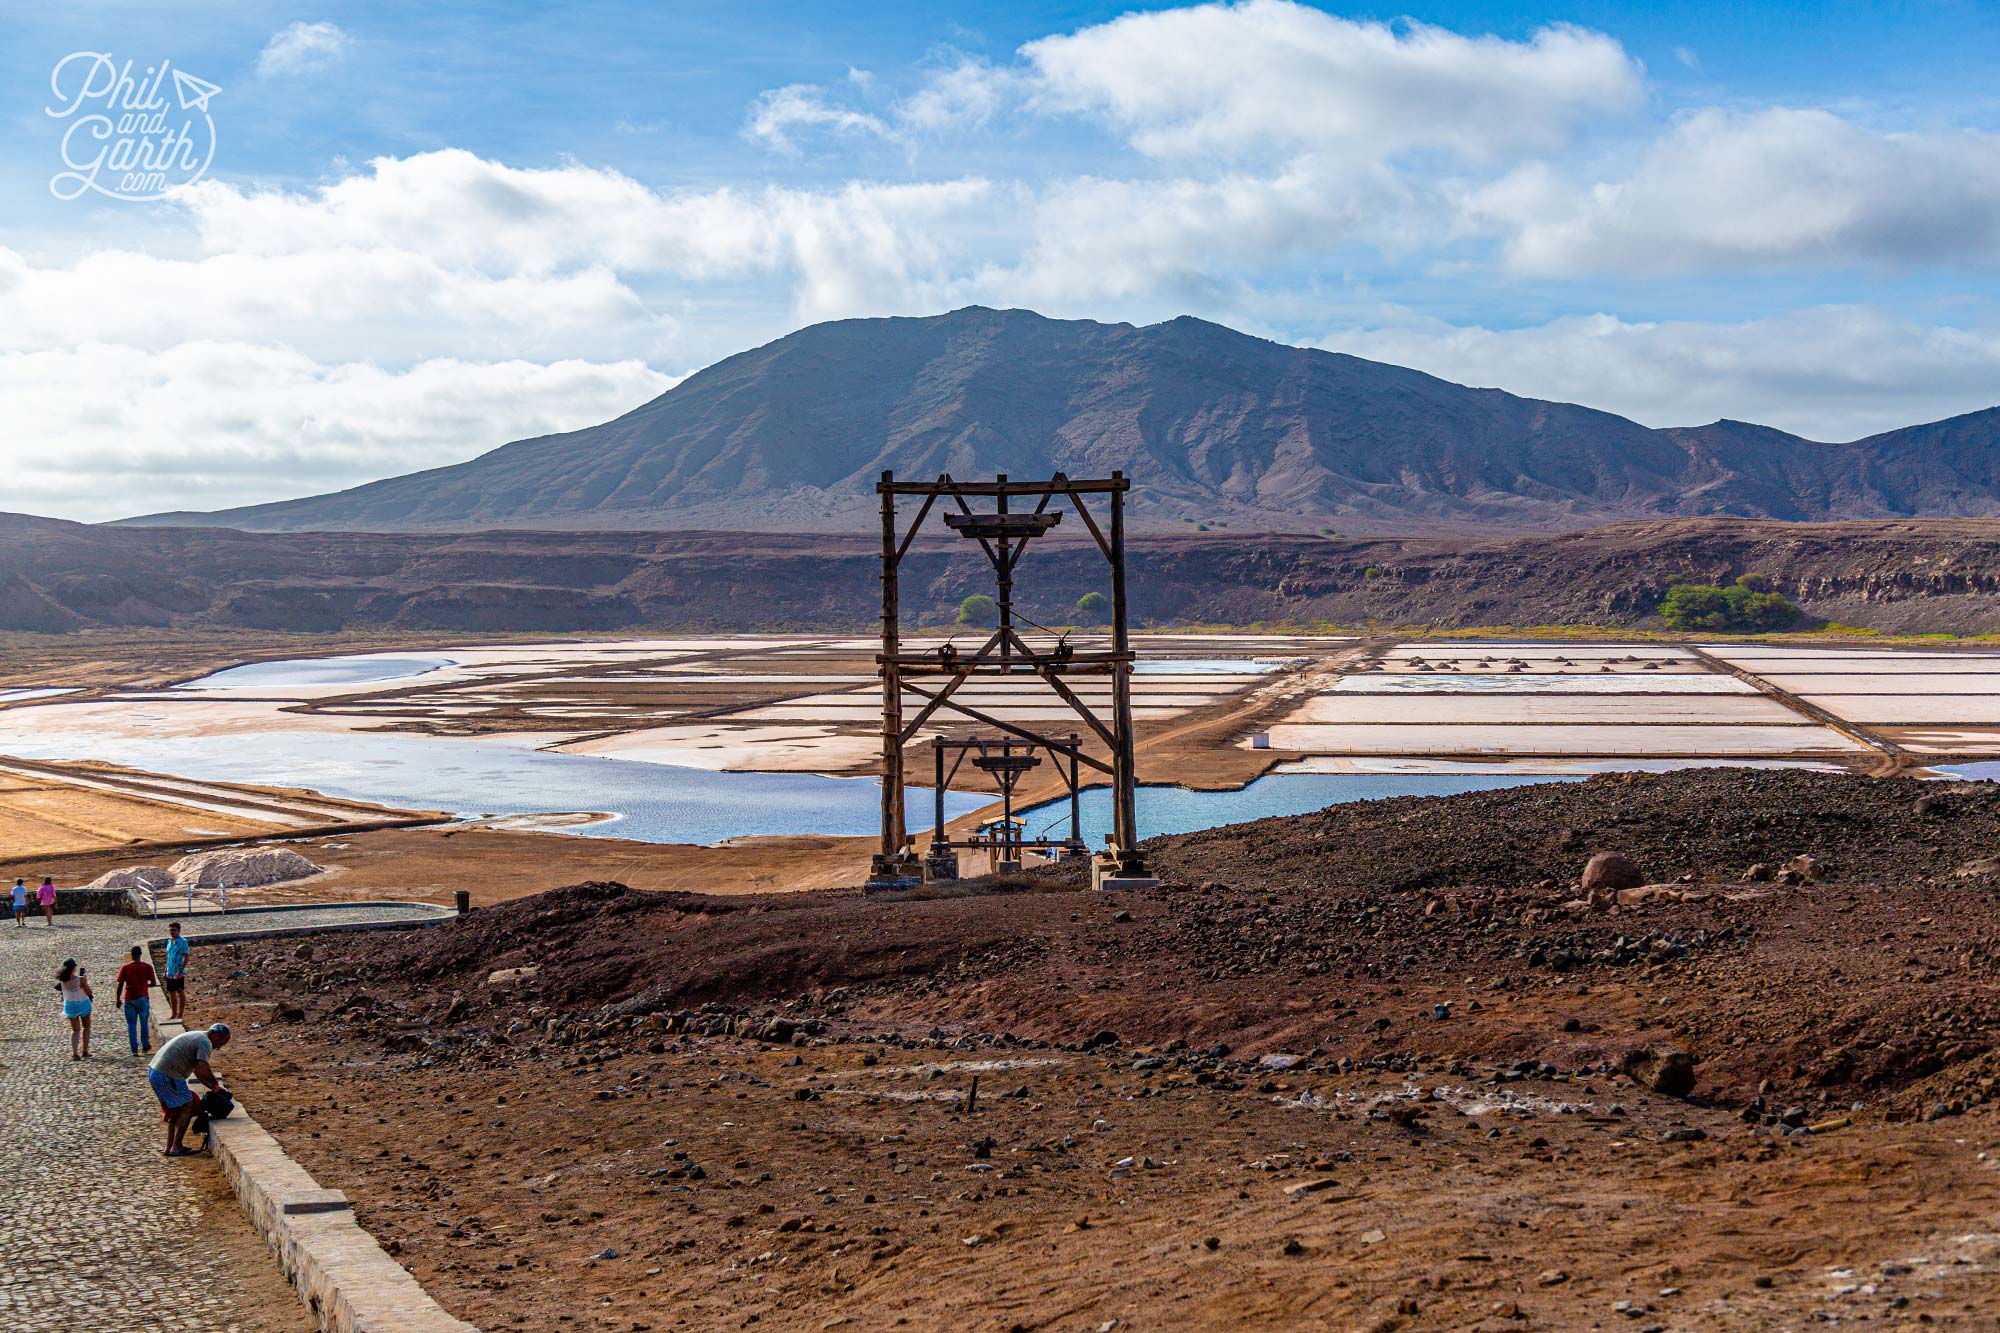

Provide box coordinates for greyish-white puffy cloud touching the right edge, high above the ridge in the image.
[1464,108,2000,276]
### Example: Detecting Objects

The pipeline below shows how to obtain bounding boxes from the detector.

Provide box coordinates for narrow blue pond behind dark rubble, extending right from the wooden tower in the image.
[1032,773,1584,849]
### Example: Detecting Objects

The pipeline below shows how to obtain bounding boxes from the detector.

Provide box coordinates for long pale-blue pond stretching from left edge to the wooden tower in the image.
[0,705,992,843]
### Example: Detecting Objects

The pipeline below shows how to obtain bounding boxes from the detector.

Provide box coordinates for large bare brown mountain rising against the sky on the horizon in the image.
[130,308,2000,534]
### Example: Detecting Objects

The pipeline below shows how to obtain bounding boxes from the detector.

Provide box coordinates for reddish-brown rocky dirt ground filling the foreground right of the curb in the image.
[207,773,2000,1331]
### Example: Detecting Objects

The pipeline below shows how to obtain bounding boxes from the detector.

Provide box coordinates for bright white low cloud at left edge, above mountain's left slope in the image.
[0,342,674,520]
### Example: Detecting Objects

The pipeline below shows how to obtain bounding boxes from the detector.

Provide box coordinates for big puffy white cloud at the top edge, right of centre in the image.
[1022,0,1642,160]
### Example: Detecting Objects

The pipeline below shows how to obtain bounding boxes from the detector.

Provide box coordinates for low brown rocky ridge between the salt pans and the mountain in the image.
[11,516,2000,632]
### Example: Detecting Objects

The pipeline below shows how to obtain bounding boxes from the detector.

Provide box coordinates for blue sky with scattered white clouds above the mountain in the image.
[0,0,2000,520]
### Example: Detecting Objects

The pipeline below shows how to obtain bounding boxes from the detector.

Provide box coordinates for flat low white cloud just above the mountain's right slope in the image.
[1320,306,2000,442]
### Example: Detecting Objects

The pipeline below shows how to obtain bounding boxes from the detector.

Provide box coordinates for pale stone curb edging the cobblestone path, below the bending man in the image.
[156,996,478,1333]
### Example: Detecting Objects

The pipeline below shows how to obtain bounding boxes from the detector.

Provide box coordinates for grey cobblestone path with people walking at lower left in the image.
[0,911,442,1333]
